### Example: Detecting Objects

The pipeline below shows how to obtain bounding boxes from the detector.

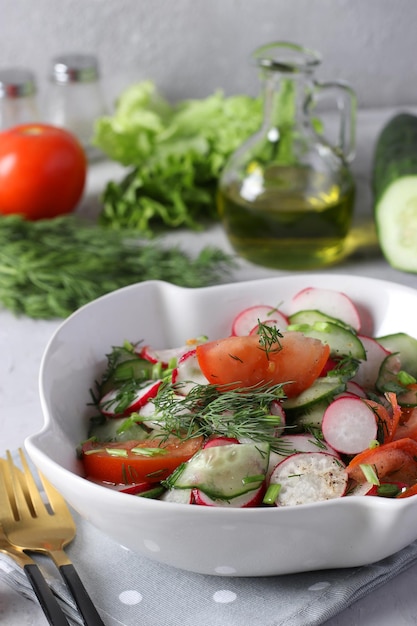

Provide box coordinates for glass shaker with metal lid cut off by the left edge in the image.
[0,68,41,130]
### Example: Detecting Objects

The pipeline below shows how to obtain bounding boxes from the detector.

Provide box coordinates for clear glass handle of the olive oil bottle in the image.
[307,81,356,162]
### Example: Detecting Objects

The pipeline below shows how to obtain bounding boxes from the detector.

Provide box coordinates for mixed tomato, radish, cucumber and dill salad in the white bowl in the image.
[78,287,417,508]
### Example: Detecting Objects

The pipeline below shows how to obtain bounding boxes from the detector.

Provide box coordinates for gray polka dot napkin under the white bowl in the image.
[0,502,417,626]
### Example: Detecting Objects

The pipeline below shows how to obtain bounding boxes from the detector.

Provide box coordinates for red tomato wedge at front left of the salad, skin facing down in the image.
[81,437,203,485]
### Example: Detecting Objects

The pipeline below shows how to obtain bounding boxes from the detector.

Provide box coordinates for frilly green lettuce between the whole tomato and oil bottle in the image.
[94,81,261,236]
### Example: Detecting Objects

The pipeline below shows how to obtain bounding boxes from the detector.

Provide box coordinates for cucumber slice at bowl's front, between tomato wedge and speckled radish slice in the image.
[167,443,270,500]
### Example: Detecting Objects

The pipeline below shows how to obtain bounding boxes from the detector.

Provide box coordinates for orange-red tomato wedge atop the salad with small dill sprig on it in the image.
[196,331,329,397]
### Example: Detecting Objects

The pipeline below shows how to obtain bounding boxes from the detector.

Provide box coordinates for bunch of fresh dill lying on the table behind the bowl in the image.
[0,215,233,319]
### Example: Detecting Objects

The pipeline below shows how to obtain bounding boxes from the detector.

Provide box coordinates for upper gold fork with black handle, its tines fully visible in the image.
[2,450,104,626]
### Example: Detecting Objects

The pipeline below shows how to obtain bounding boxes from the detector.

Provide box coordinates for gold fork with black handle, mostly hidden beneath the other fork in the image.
[0,459,69,626]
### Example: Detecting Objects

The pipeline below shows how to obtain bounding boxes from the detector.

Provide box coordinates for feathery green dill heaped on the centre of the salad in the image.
[152,383,290,452]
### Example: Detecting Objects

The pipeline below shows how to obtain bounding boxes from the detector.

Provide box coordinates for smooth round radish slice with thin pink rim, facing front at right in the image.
[322,398,378,454]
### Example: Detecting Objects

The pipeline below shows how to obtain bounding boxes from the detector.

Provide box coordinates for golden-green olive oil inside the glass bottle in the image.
[218,166,355,270]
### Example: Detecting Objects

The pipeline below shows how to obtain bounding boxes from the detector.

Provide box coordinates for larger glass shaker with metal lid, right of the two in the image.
[45,54,107,161]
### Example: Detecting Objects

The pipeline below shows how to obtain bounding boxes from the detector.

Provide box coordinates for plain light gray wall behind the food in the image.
[0,0,417,108]
